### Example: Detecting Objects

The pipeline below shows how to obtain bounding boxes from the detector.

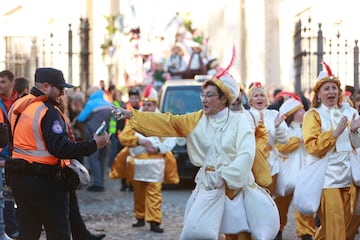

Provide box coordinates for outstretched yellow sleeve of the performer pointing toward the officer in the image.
[129,110,203,137]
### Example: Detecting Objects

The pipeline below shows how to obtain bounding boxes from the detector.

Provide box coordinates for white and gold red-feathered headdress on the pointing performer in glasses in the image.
[211,45,240,104]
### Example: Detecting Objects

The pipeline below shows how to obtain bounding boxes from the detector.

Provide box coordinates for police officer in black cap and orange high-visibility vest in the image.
[6,68,110,240]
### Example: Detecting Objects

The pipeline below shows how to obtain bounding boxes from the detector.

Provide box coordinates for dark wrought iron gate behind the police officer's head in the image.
[4,18,90,91]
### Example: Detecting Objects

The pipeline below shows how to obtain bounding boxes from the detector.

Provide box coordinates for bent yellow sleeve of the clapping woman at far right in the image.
[302,110,336,158]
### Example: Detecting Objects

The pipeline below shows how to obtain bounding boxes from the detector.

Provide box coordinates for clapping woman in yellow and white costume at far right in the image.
[303,63,360,240]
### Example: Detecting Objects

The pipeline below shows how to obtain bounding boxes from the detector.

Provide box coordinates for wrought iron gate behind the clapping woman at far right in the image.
[294,17,359,93]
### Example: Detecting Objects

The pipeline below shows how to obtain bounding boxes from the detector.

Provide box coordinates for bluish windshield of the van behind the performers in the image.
[160,86,202,114]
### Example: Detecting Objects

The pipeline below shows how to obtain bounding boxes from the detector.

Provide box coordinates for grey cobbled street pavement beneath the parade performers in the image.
[37,176,360,240]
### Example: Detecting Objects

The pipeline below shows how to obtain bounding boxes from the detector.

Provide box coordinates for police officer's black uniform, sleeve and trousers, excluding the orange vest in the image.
[9,88,97,240]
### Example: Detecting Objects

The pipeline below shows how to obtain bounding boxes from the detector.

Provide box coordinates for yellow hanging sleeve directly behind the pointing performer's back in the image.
[251,121,272,188]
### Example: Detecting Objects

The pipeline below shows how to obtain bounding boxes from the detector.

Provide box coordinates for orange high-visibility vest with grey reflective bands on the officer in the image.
[9,94,66,165]
